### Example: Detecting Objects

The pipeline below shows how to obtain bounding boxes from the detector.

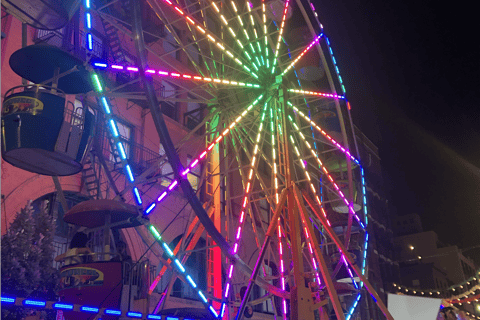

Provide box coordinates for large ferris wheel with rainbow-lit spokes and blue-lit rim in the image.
[1,0,391,319]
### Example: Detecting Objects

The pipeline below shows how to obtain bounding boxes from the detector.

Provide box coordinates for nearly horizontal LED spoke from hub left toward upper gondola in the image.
[93,62,260,88]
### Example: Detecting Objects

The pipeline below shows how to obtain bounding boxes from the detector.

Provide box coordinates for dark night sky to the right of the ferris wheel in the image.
[315,0,480,260]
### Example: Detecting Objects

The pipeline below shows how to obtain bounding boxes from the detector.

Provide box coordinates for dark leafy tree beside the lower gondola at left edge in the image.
[1,202,58,319]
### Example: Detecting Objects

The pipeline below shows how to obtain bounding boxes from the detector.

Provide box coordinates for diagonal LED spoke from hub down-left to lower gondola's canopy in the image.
[144,94,263,215]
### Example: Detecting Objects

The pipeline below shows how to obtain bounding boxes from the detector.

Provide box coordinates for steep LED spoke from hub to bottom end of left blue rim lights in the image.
[221,102,268,310]
